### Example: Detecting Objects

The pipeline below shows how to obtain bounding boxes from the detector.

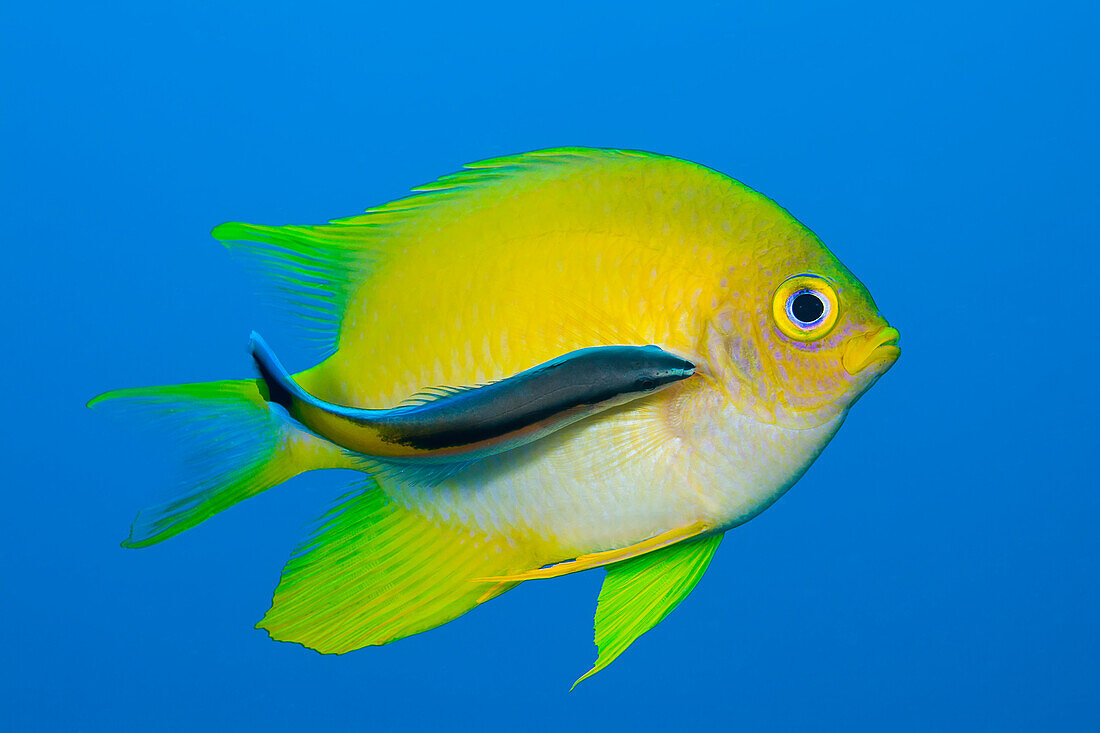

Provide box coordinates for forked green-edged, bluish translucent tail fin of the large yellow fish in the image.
[88,380,344,547]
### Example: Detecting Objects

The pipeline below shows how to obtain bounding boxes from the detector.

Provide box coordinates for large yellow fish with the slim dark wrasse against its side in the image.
[89,147,900,685]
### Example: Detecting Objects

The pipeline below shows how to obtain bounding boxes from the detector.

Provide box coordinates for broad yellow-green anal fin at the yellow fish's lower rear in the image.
[256,480,531,654]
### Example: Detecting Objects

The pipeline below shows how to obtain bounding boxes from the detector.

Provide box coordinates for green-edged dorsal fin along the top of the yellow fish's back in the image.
[212,147,662,358]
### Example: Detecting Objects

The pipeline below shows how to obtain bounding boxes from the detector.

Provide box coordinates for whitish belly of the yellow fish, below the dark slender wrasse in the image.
[386,391,844,564]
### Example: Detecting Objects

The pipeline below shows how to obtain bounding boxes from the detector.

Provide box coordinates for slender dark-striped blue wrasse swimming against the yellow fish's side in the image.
[249,332,695,462]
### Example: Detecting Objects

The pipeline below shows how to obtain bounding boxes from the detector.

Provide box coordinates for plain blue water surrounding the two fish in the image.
[0,1,1100,731]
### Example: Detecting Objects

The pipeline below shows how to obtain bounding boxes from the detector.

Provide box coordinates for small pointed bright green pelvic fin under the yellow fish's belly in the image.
[573,534,723,688]
